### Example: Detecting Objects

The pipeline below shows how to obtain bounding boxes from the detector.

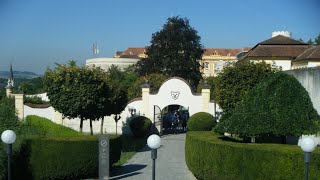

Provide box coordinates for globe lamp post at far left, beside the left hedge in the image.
[1,130,16,180]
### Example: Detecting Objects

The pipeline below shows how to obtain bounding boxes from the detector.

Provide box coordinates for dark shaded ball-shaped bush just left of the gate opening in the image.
[129,116,152,137]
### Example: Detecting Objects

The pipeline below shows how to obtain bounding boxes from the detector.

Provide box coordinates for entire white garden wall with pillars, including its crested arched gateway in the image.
[15,77,221,134]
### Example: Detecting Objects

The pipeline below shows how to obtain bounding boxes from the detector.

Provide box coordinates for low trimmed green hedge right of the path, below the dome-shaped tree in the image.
[185,131,320,180]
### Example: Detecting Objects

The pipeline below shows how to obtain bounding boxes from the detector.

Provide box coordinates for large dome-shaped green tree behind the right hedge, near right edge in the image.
[218,72,320,142]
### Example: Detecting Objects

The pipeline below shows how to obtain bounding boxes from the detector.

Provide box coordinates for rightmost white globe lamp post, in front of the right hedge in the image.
[300,137,316,180]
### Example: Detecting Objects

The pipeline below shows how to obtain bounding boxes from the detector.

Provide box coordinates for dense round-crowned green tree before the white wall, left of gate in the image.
[44,62,112,134]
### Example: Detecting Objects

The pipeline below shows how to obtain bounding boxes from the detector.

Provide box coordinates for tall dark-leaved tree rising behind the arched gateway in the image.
[137,17,204,87]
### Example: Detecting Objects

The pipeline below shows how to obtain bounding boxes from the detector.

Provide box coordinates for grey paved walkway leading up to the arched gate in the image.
[110,134,196,180]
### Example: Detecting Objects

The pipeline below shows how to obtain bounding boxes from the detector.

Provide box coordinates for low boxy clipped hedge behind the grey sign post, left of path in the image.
[13,136,121,180]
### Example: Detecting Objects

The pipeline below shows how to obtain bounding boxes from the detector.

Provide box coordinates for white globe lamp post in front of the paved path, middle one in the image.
[147,134,161,180]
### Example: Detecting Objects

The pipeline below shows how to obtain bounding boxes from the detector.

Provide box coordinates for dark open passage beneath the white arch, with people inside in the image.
[160,104,189,135]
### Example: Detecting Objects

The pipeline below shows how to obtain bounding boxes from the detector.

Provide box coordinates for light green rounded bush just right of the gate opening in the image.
[187,112,217,131]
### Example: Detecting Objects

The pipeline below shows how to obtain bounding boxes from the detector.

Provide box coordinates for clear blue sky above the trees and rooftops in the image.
[0,0,320,74]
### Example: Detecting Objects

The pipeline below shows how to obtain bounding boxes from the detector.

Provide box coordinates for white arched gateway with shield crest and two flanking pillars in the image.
[127,77,219,132]
